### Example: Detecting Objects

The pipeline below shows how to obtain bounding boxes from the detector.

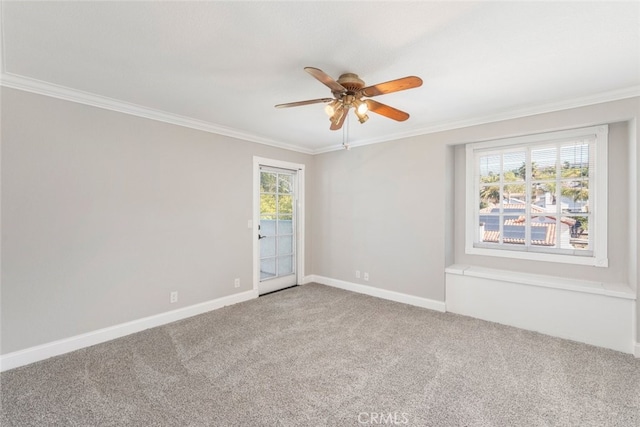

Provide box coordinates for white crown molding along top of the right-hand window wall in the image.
[312,85,640,154]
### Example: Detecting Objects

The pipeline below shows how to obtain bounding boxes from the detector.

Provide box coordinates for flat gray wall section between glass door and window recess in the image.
[311,136,447,301]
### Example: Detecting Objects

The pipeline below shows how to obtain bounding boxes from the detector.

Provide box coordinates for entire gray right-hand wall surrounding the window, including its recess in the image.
[312,98,640,340]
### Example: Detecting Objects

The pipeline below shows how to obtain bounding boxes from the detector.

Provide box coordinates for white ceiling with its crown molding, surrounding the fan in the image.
[0,1,640,153]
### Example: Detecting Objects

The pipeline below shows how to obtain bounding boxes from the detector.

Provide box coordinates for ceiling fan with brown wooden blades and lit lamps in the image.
[275,67,422,130]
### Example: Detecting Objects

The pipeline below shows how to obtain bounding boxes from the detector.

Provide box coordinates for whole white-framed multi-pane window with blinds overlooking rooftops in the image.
[466,126,608,267]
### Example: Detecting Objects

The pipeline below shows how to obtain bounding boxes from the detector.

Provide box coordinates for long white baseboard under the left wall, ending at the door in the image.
[0,290,258,372]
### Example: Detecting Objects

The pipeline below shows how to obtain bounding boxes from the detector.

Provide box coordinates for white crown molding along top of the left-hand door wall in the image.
[0,72,313,154]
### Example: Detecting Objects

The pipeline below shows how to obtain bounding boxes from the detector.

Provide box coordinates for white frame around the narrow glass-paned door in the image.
[251,156,305,292]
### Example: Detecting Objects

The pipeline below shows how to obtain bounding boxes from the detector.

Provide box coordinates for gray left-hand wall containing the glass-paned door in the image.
[0,88,313,354]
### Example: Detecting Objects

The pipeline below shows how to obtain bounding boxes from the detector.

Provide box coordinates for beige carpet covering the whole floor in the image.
[0,284,640,427]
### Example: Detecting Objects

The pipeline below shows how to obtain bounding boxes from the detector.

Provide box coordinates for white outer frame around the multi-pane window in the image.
[465,125,609,267]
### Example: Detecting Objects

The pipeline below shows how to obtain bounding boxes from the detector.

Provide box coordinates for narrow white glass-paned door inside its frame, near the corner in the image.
[256,165,298,294]
